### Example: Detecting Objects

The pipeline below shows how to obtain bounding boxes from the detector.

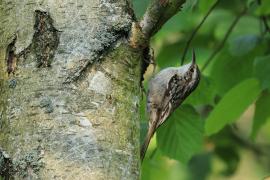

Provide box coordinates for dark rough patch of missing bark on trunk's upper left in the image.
[5,10,60,74]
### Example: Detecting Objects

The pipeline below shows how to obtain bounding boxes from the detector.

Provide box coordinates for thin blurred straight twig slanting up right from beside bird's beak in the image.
[201,8,246,72]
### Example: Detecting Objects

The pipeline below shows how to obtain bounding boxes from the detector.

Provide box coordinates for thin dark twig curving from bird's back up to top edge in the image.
[181,0,219,65]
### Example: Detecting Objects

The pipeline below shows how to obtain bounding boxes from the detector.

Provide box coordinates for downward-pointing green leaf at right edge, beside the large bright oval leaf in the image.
[251,91,270,140]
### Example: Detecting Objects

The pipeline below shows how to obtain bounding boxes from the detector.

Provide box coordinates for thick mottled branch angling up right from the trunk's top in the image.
[140,0,185,39]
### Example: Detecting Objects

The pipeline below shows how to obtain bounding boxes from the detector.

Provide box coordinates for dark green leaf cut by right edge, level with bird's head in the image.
[254,55,270,89]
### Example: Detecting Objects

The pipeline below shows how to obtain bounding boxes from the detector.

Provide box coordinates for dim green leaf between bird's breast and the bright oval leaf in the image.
[184,75,216,105]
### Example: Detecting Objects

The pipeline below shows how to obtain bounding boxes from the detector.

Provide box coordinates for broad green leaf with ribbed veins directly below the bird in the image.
[157,105,203,163]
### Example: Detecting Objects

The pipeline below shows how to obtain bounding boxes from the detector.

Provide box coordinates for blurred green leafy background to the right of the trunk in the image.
[133,0,270,180]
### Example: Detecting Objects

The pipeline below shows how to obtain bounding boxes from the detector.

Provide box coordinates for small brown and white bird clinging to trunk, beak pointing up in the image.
[140,50,200,161]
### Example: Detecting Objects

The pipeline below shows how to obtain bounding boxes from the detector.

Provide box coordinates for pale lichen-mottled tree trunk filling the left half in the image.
[0,0,141,180]
